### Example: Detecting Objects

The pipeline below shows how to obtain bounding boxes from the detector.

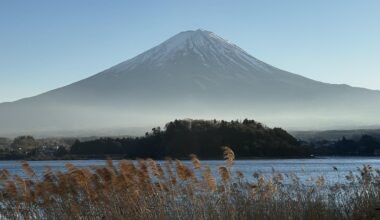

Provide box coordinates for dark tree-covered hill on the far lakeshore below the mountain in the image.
[70,119,309,159]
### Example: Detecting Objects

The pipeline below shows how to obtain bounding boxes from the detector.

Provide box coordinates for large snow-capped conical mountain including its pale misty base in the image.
[0,30,380,135]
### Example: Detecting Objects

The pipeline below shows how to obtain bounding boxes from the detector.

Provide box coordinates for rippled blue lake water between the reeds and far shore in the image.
[0,157,380,184]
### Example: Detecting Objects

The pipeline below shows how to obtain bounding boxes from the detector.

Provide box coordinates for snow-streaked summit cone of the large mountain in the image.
[113,29,266,70]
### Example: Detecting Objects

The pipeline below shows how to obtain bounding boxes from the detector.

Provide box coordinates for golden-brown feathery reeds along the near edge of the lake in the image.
[0,147,380,219]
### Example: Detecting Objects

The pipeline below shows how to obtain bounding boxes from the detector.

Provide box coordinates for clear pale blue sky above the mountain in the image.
[0,0,380,102]
